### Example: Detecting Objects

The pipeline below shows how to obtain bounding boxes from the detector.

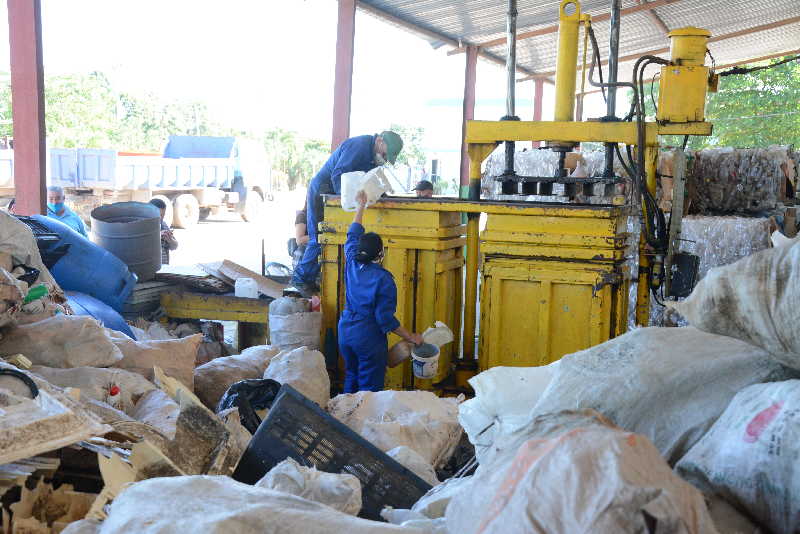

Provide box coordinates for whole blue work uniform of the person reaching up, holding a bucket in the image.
[339,222,400,393]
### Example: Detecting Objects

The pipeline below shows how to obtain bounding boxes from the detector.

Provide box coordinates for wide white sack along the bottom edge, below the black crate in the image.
[100,475,432,534]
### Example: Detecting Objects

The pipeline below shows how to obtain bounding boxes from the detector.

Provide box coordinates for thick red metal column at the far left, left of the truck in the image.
[8,0,47,215]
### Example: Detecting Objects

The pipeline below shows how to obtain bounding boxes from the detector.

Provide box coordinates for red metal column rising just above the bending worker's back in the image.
[331,0,356,150]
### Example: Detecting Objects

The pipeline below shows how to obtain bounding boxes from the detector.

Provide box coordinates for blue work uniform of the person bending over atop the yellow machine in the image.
[292,135,377,284]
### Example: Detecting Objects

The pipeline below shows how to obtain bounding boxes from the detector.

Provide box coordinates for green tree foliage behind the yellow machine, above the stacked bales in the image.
[645,58,800,149]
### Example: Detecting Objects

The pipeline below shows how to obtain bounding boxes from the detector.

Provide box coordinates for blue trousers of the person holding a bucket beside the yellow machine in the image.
[339,311,389,393]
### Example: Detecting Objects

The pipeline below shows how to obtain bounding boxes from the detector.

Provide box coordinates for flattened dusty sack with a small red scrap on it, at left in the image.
[31,365,156,415]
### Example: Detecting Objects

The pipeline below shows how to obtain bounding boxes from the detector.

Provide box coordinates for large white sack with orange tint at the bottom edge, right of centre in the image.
[446,415,717,534]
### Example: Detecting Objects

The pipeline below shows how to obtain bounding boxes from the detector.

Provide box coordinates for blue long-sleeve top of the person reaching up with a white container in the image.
[344,222,400,334]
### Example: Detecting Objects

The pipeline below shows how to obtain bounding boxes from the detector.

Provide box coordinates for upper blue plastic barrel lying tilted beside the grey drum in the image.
[33,215,136,312]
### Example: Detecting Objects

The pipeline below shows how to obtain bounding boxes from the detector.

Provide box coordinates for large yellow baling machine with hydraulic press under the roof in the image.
[320,0,715,391]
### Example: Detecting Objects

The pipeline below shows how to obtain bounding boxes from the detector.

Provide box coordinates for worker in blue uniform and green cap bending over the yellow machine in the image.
[292,130,403,295]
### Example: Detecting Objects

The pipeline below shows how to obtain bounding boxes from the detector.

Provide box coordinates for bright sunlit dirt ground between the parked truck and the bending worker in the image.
[170,189,305,273]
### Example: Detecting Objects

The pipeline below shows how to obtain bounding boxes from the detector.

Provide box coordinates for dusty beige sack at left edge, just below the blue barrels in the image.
[0,315,122,368]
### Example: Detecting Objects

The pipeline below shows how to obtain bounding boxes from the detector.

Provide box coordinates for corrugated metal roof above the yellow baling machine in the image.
[358,0,800,84]
